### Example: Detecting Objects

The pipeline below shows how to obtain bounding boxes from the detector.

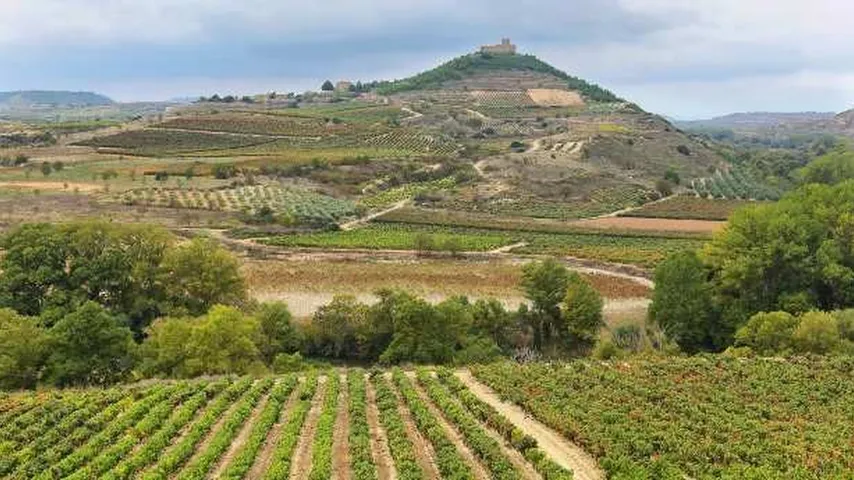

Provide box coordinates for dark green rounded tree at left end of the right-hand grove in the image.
[649,251,731,352]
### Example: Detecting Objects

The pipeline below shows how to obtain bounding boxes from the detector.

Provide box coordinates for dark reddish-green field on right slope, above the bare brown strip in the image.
[620,195,761,220]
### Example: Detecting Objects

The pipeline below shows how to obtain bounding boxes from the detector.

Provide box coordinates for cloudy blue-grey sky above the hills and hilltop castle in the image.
[0,0,854,119]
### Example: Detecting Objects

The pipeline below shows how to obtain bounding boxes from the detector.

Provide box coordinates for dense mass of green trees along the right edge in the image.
[650,147,854,354]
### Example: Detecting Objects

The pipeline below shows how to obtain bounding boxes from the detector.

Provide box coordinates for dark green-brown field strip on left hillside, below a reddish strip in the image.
[78,129,273,156]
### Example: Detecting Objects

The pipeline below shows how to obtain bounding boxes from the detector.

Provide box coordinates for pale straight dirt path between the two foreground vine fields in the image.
[456,370,605,480]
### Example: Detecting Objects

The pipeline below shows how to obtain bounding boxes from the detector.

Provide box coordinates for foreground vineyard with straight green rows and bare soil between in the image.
[0,370,573,480]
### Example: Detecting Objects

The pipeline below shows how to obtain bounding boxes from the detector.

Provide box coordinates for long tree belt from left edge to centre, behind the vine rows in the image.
[0,222,603,389]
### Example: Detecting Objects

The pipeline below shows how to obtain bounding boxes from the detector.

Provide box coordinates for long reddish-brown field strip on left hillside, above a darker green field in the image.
[157,113,353,137]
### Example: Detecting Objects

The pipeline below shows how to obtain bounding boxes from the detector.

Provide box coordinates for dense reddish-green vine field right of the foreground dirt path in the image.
[472,357,854,480]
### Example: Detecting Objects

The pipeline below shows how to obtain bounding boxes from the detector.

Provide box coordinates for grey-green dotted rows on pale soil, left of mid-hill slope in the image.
[118,185,356,224]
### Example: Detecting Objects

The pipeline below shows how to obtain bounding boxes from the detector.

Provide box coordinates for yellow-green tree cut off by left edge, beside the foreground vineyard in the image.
[0,309,48,390]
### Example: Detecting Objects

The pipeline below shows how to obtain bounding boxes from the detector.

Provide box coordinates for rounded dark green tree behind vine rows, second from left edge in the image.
[45,302,136,387]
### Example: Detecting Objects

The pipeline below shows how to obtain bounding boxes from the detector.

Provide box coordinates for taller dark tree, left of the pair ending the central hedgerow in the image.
[522,258,569,349]
